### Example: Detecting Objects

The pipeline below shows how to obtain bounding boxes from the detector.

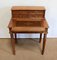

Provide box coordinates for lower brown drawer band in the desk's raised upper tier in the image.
[12,14,43,19]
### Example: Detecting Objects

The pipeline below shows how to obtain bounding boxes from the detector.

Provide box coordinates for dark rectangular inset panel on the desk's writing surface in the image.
[15,21,41,27]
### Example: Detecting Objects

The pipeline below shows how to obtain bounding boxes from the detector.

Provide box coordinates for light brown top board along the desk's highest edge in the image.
[11,6,45,10]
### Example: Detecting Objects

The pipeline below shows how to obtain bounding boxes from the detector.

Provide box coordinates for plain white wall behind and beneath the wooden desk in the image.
[0,0,57,38]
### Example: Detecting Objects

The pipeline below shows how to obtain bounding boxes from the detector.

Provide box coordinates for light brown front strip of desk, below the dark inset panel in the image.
[12,27,45,33]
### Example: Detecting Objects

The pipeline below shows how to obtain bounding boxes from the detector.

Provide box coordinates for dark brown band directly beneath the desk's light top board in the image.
[12,10,44,14]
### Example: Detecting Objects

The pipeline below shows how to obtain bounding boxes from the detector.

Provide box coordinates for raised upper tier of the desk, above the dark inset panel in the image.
[11,6,45,21]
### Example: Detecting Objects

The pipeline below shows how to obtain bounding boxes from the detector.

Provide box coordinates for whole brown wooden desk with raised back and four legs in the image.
[8,6,48,55]
